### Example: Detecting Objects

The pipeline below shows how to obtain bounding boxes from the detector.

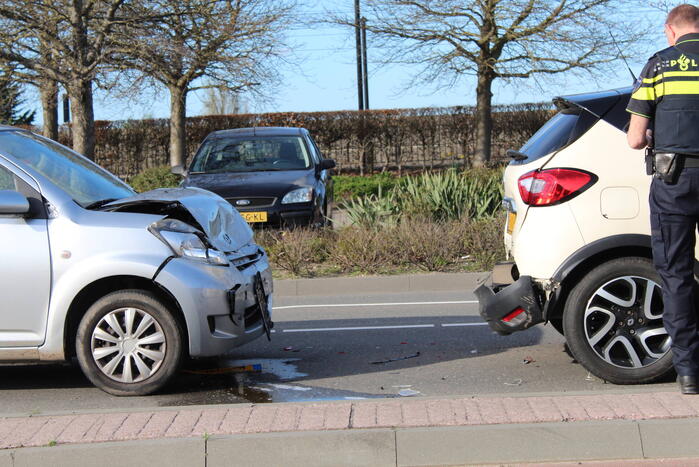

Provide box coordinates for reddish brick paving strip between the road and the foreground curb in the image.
[0,392,699,449]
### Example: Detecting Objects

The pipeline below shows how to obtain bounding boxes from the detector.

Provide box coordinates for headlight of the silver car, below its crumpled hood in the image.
[148,219,229,266]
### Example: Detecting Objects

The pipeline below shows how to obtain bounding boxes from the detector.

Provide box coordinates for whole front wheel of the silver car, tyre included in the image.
[76,290,183,396]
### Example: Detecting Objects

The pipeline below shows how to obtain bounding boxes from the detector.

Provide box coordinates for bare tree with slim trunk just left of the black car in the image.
[116,0,291,166]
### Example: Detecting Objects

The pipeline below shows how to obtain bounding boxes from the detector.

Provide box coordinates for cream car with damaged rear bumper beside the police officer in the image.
[476,88,676,384]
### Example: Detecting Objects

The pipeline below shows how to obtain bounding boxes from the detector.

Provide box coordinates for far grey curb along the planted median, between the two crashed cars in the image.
[274,272,488,297]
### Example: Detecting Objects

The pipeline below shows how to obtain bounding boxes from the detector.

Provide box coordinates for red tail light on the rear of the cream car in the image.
[518,169,597,206]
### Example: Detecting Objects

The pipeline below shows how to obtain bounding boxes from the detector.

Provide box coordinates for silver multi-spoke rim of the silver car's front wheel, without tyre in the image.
[90,308,166,383]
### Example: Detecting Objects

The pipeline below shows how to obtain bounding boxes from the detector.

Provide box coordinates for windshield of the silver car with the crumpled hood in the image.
[0,131,135,207]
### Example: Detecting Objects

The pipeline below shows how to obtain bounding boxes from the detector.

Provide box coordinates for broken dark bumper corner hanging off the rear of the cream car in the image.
[474,263,544,335]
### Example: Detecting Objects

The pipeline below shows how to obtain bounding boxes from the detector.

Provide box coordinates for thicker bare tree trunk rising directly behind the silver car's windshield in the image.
[68,80,95,160]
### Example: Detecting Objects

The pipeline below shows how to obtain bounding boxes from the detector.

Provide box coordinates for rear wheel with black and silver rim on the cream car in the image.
[563,257,673,384]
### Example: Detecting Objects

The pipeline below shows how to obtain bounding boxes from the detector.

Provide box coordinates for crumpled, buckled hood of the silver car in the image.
[103,188,253,252]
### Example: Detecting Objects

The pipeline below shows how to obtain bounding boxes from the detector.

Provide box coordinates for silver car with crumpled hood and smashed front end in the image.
[0,127,272,395]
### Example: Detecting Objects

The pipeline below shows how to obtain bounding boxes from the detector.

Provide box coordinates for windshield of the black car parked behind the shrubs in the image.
[190,136,311,173]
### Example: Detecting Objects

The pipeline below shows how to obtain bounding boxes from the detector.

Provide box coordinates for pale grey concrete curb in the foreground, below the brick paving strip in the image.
[0,418,699,467]
